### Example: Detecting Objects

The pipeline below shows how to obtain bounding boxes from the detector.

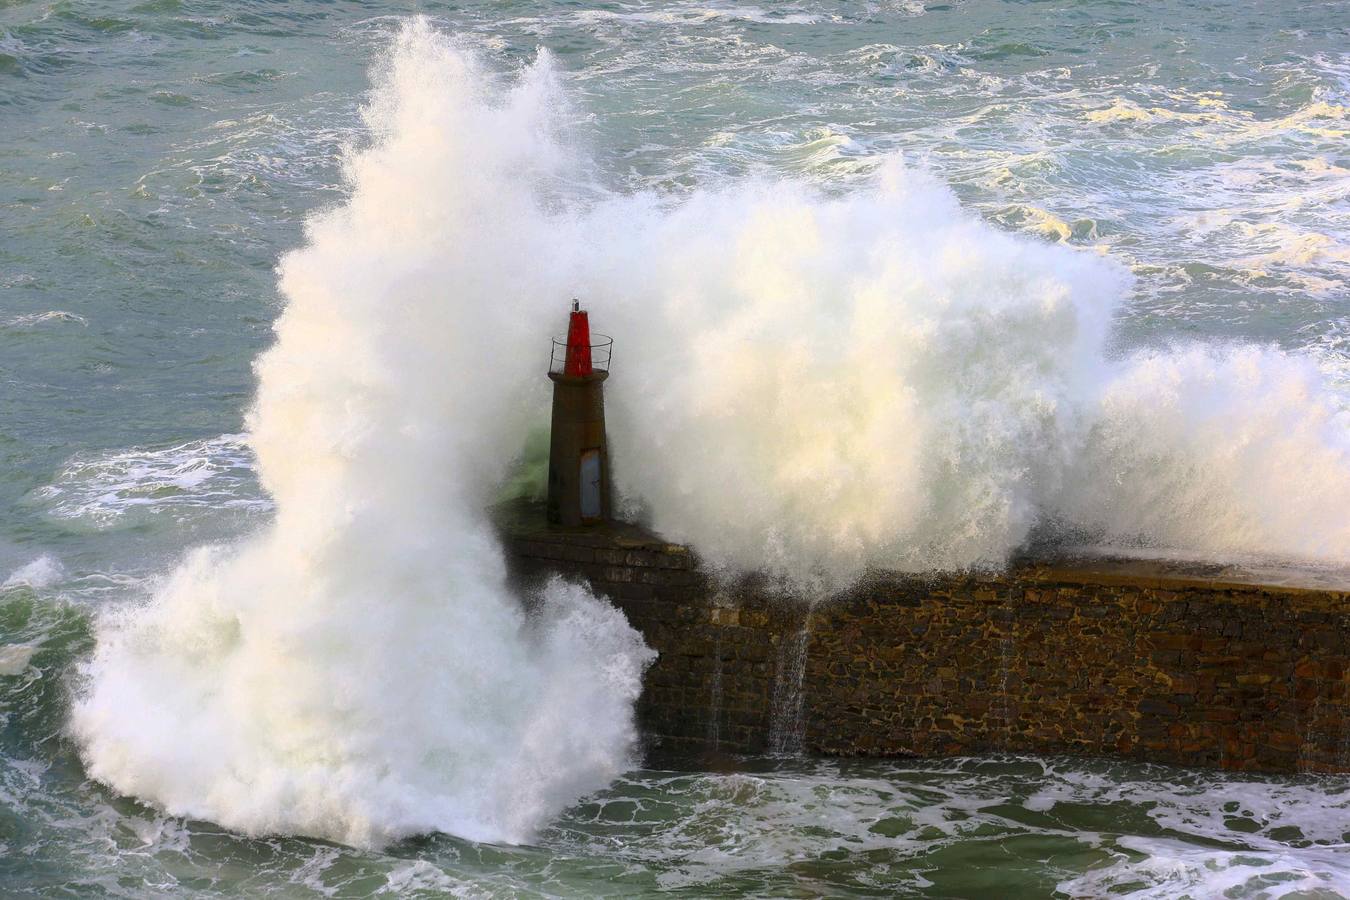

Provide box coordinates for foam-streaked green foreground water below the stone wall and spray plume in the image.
[0,588,1350,897]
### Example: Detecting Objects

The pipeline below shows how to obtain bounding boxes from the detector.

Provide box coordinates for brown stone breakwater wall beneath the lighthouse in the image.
[504,507,1350,772]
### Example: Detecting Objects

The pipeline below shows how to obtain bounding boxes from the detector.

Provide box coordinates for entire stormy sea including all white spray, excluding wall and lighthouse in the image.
[0,0,1350,899]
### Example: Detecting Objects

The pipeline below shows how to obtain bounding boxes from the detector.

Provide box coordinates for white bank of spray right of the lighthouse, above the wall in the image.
[599,175,1350,586]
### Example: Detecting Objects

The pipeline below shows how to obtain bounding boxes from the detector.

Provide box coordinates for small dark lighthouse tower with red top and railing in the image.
[548,300,614,525]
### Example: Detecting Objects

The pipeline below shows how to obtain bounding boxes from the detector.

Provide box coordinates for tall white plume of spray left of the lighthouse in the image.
[73,24,651,845]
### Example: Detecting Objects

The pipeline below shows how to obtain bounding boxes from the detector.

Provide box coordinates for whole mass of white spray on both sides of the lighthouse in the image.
[73,20,1350,845]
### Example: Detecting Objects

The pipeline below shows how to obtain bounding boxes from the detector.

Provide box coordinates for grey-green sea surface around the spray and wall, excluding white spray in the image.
[0,0,1350,899]
